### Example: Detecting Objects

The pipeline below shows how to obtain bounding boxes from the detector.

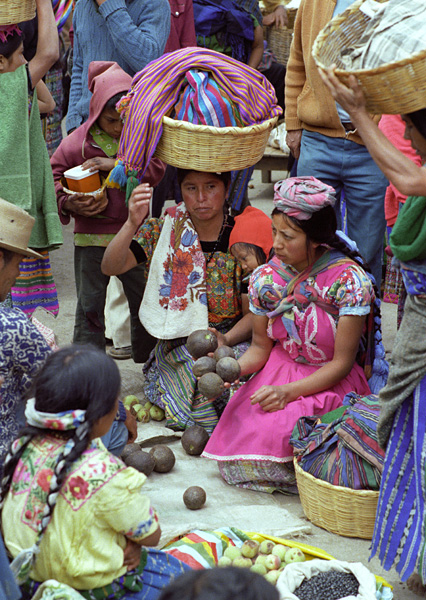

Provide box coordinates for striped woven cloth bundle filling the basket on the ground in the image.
[290,392,384,490]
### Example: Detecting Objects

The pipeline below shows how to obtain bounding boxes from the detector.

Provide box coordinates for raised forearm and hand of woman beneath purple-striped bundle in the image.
[101,183,152,275]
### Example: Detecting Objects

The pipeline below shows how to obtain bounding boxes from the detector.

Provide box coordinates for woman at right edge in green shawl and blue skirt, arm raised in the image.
[321,68,426,596]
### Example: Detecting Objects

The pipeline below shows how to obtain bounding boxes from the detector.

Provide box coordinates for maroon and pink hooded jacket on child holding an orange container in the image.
[50,61,165,234]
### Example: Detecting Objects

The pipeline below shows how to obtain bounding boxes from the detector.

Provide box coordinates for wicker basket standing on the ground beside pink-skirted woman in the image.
[294,459,379,540]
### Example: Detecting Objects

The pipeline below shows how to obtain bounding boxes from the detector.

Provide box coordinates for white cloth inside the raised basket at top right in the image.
[340,0,426,70]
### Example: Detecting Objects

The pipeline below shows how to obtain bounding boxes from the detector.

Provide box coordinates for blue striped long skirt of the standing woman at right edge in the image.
[371,377,426,583]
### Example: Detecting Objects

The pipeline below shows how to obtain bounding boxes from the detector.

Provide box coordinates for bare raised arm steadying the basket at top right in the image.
[320,67,426,196]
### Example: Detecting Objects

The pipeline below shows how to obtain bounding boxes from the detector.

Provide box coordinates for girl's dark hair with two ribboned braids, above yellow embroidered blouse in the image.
[0,345,120,539]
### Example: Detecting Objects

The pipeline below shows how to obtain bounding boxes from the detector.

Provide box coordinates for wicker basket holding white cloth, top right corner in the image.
[312,0,426,114]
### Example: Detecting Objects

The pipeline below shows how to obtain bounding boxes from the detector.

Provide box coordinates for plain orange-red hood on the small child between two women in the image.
[229,206,273,258]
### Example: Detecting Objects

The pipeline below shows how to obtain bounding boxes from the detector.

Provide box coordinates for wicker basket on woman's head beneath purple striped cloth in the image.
[155,116,278,173]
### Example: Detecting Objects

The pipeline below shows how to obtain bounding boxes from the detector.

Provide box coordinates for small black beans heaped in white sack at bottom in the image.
[293,571,359,600]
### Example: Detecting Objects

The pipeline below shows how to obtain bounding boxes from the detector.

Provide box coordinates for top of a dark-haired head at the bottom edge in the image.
[158,567,279,600]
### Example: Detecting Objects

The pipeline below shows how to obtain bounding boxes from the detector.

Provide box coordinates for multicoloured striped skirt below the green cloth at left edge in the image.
[10,250,59,317]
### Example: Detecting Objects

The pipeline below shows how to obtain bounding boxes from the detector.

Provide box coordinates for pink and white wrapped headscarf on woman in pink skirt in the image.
[274,176,336,221]
